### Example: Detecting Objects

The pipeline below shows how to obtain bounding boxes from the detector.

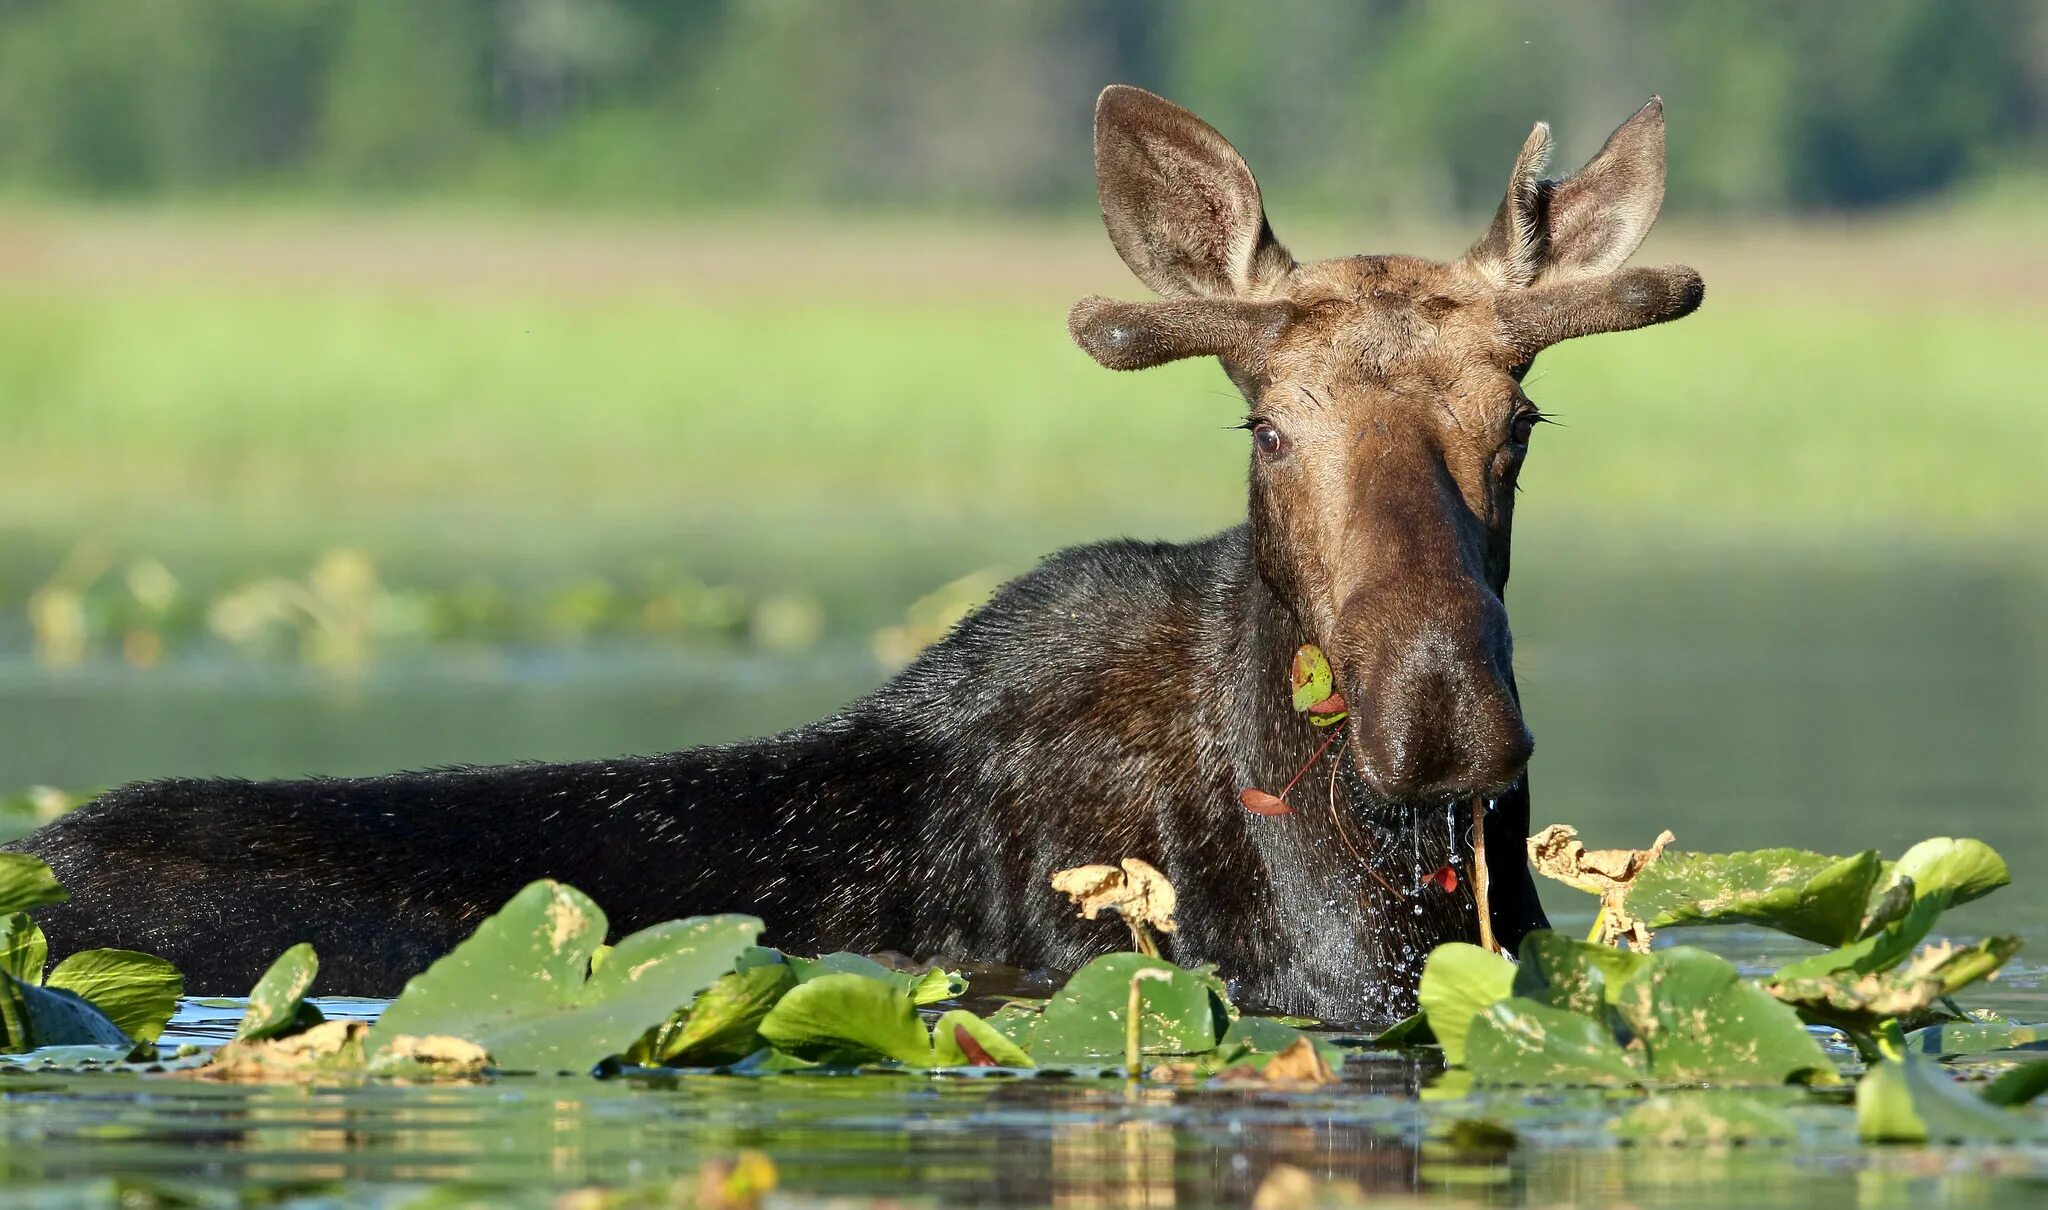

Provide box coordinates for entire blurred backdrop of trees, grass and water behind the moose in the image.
[0,0,2048,909]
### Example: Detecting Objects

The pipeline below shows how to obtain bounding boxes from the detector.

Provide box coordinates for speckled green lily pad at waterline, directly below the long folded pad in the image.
[1614,946,1835,1085]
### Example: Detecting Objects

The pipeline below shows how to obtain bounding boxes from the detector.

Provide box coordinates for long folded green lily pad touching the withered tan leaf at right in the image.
[1622,850,1882,946]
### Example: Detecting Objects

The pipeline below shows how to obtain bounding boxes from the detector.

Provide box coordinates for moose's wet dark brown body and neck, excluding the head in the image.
[8,526,1542,1022]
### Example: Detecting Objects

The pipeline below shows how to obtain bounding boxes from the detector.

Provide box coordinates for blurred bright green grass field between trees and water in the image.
[0,217,2048,573]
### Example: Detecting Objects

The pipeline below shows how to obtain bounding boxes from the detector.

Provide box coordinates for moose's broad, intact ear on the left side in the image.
[1096,84,1294,299]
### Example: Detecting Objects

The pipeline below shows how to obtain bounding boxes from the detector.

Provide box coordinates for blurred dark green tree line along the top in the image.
[0,0,2048,213]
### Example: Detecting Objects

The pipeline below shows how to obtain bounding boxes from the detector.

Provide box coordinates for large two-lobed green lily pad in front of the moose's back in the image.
[369,880,762,1071]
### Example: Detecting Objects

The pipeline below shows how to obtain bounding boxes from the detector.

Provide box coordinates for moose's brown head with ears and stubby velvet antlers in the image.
[1069,86,1704,798]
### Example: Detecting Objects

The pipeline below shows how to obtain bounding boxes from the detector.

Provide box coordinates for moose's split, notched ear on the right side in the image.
[1466,96,1665,289]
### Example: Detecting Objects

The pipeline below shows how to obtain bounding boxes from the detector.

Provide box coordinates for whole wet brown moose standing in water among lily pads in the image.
[12,86,1704,1024]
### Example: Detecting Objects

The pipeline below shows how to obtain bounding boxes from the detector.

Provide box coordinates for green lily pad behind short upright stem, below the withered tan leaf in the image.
[1030,954,1221,1067]
